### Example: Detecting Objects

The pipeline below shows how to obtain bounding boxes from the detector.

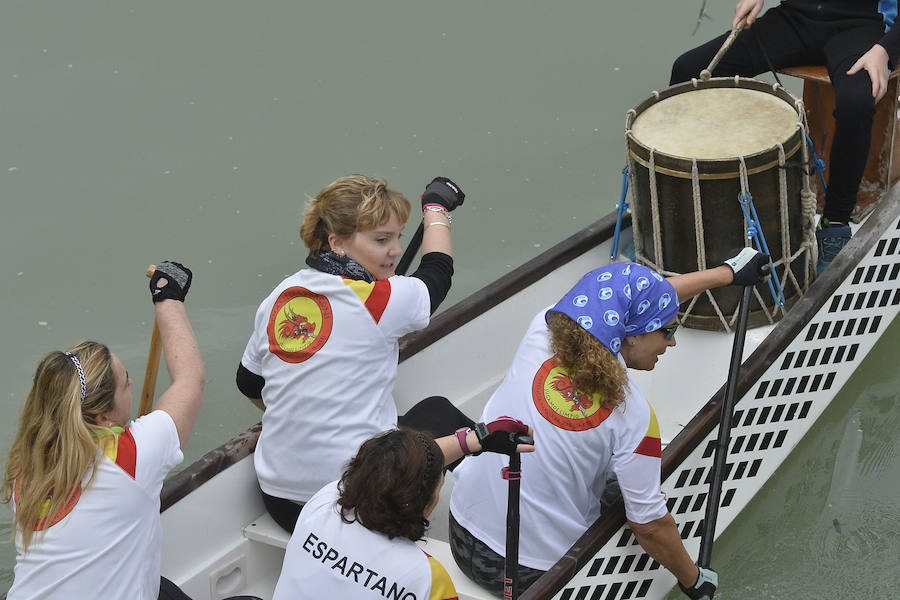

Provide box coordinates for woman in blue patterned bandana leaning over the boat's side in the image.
[450,249,769,597]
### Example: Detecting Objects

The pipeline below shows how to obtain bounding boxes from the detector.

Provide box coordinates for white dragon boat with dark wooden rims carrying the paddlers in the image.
[149,170,900,600]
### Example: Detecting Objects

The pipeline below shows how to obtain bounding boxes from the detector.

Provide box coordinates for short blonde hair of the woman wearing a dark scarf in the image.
[300,175,412,256]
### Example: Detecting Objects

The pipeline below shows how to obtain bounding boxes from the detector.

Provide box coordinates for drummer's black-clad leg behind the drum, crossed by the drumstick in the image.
[669,7,823,85]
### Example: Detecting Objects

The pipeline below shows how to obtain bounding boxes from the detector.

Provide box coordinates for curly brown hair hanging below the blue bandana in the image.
[547,311,628,408]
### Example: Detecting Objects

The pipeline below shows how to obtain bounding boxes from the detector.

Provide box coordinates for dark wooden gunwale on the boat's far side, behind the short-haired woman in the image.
[160,212,631,512]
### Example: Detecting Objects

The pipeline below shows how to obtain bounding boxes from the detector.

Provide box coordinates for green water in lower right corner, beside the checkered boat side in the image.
[668,319,900,600]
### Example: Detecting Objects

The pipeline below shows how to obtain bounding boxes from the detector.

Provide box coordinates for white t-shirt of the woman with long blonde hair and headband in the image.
[7,410,184,600]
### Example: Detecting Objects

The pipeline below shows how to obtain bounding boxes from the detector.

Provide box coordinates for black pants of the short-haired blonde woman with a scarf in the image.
[262,396,475,533]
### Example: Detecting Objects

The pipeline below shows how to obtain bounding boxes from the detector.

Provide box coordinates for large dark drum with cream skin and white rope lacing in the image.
[625,77,815,330]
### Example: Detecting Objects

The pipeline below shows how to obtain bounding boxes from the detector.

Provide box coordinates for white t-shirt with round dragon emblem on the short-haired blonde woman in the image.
[241,269,431,502]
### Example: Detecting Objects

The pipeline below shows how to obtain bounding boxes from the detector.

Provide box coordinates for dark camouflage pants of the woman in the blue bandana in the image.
[450,512,545,597]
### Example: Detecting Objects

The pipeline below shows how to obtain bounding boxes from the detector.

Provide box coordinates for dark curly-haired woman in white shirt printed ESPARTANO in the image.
[274,420,533,600]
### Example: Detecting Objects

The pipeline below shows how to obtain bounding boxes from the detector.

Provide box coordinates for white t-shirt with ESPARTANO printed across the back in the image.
[273,481,457,600]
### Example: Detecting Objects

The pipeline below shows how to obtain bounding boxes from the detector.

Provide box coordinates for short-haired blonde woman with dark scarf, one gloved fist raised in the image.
[237,175,492,531]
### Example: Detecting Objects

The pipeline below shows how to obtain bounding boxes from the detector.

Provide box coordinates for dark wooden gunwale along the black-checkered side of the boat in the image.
[520,186,900,600]
